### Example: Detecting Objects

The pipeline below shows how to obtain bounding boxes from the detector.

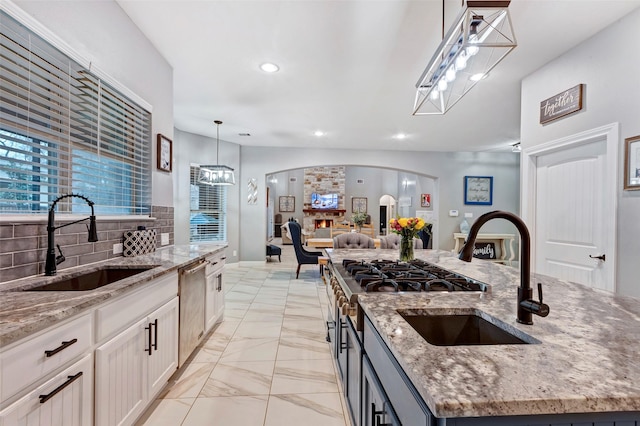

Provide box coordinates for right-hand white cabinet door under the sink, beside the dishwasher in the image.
[145,297,178,398]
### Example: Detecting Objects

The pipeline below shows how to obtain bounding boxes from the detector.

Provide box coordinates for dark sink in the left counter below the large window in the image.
[19,265,156,291]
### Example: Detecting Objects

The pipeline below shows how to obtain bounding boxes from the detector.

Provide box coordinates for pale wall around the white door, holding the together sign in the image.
[521,9,640,297]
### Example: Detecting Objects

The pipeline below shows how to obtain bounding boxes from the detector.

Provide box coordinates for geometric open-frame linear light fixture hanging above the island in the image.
[413,0,517,115]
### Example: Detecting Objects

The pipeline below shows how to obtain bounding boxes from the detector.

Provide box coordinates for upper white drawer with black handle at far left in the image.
[0,315,93,401]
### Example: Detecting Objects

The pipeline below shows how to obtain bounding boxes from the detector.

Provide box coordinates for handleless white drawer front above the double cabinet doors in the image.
[96,272,178,343]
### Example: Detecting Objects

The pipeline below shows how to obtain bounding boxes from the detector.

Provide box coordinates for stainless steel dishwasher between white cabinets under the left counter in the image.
[178,261,207,366]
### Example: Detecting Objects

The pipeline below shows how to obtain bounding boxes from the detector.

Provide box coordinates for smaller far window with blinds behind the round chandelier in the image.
[189,166,227,242]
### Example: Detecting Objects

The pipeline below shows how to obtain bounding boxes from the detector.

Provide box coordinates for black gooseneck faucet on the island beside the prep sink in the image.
[458,210,549,325]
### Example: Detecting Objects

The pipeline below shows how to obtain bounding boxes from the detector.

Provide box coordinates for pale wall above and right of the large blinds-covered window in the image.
[14,0,176,206]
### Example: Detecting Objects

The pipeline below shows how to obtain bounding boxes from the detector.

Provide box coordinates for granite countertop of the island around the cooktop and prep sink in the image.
[327,250,640,418]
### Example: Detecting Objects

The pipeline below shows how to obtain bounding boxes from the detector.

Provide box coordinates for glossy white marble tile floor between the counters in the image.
[136,243,350,426]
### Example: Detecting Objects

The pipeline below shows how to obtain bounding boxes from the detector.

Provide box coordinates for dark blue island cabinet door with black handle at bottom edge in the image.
[361,355,400,426]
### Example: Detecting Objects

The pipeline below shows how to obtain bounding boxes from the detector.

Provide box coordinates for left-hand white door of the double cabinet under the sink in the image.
[95,318,149,426]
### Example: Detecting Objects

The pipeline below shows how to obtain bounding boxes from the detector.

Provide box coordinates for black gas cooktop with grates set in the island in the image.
[334,259,487,292]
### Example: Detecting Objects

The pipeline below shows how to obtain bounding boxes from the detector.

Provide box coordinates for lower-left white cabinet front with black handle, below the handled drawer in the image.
[0,355,93,426]
